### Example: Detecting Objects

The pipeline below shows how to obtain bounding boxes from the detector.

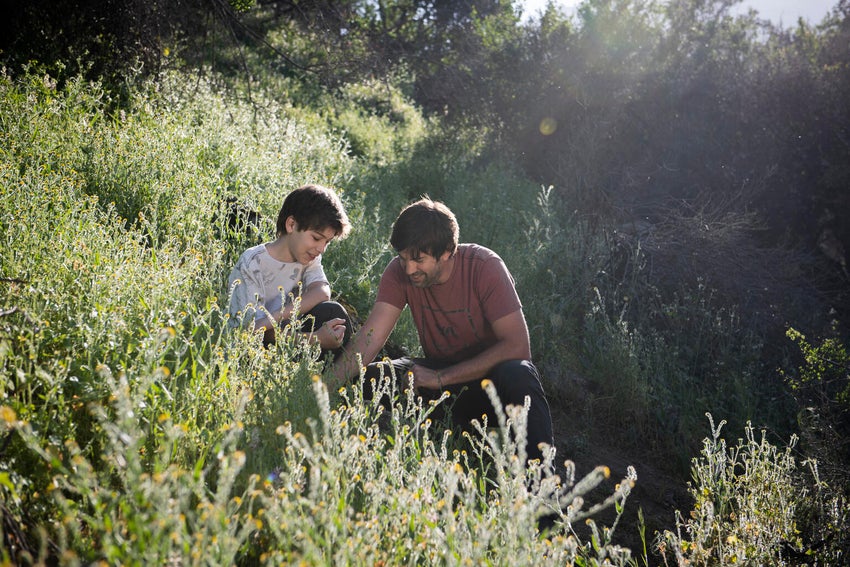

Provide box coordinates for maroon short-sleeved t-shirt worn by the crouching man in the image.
[377,244,522,363]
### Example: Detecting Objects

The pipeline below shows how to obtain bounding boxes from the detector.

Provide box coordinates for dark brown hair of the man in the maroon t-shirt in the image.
[390,197,460,258]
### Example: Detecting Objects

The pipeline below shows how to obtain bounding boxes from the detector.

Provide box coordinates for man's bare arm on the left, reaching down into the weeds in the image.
[331,301,401,387]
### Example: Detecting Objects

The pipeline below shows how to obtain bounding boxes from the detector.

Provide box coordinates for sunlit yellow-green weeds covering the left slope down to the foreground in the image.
[0,67,633,565]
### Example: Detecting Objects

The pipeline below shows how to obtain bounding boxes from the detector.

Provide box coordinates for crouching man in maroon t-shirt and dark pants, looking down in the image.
[336,199,554,459]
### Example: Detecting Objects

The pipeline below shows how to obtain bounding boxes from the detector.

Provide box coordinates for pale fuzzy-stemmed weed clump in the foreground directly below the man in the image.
[242,370,634,565]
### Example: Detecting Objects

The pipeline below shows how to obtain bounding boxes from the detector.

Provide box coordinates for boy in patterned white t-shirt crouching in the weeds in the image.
[228,185,351,353]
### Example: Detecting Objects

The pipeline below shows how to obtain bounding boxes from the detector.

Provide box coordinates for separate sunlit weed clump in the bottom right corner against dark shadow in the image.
[656,414,850,565]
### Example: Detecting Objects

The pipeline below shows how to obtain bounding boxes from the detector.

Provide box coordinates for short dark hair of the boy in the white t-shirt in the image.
[277,184,351,238]
